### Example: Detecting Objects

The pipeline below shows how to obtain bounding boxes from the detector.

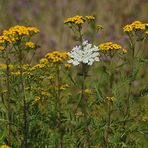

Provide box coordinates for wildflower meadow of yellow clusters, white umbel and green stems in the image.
[0,4,148,148]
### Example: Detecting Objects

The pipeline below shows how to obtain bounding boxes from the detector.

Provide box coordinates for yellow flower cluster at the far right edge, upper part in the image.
[123,21,147,32]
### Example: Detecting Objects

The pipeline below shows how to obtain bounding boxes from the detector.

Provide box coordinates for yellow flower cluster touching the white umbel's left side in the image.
[45,51,68,63]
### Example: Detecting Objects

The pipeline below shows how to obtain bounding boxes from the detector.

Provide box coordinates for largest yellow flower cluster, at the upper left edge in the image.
[0,25,39,43]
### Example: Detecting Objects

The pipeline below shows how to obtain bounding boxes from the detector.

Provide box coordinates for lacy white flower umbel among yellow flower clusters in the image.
[68,40,100,66]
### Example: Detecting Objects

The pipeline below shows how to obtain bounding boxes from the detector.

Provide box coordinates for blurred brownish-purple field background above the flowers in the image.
[0,0,148,58]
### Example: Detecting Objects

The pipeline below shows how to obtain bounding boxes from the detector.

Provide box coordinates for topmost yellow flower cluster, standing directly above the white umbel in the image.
[64,15,95,25]
